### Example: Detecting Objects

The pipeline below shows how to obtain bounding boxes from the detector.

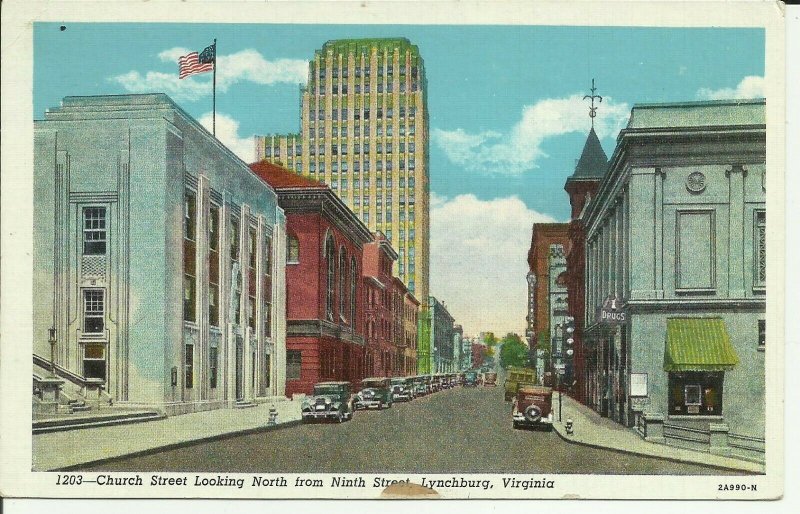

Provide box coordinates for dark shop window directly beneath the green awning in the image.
[669,371,724,416]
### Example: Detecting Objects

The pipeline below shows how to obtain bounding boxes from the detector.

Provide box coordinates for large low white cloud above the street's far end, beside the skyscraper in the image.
[430,194,555,335]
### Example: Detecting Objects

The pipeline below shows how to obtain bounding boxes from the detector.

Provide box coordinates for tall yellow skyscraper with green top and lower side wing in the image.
[256,38,429,298]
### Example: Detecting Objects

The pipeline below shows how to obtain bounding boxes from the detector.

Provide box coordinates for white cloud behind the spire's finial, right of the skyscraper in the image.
[432,94,630,175]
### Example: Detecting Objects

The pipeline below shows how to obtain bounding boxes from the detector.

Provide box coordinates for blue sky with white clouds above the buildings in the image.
[34,23,764,333]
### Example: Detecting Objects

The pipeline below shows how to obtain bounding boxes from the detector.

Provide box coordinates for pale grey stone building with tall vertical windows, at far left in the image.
[33,94,286,414]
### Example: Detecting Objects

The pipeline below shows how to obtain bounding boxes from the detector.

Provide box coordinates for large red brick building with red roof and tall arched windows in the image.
[250,161,374,396]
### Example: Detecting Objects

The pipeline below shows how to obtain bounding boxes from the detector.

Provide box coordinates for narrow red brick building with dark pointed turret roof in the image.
[564,128,608,403]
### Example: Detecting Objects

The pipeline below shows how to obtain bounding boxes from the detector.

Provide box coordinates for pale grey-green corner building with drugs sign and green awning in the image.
[583,100,766,456]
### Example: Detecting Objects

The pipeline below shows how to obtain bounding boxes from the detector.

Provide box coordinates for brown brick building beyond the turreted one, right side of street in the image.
[526,223,568,377]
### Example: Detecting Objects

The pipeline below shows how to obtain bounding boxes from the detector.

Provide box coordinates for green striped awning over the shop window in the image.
[664,318,739,371]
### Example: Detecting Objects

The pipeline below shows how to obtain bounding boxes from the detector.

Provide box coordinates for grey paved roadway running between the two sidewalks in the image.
[87,387,736,475]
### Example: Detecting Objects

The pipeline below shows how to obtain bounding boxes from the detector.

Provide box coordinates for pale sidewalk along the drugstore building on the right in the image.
[553,392,765,473]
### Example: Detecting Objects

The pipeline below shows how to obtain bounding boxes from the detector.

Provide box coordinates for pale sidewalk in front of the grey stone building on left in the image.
[33,400,300,471]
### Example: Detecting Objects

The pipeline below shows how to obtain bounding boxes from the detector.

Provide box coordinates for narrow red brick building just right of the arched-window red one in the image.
[363,232,397,377]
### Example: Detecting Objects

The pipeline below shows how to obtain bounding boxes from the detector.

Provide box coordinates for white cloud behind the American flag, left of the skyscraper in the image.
[109,47,308,101]
